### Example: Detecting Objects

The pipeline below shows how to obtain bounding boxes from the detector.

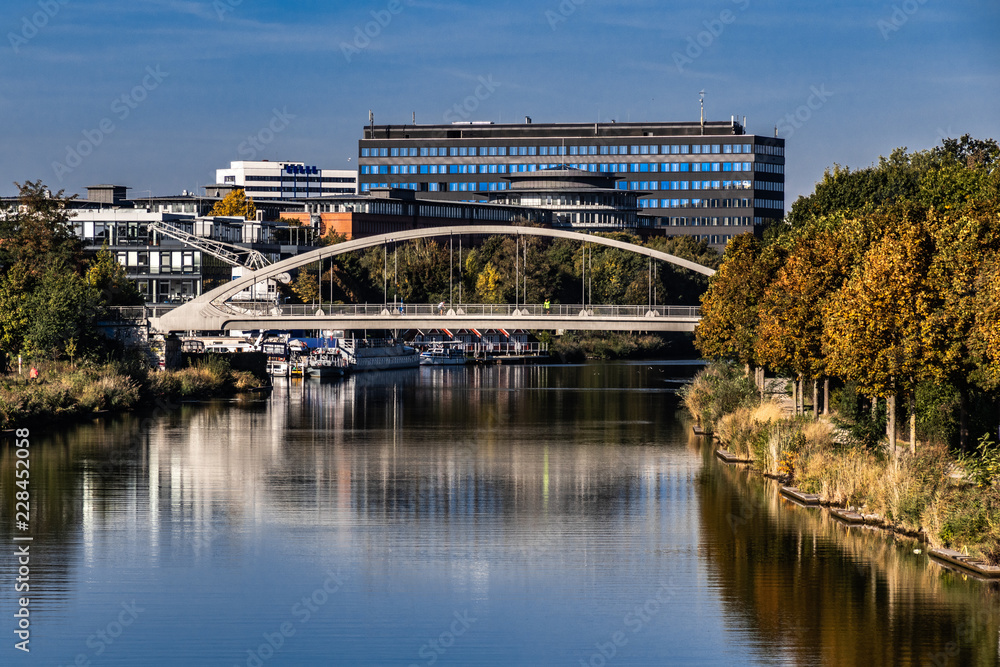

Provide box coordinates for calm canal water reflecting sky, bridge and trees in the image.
[0,362,1000,667]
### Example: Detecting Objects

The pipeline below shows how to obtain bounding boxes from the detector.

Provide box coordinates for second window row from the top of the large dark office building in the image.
[360,162,785,176]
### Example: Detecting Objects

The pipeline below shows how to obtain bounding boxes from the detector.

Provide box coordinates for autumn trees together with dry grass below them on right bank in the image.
[684,136,1000,564]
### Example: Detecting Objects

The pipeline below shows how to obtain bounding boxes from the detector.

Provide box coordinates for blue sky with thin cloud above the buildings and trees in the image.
[0,0,1000,209]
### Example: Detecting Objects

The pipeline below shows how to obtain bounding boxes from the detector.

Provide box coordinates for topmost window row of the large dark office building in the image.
[361,144,785,157]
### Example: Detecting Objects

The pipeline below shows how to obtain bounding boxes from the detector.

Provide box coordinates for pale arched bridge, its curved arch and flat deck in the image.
[150,225,715,332]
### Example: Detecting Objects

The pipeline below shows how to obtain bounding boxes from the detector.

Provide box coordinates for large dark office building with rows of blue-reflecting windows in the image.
[358,119,785,245]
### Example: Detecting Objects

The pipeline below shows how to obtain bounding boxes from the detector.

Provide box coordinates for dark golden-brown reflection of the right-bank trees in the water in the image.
[699,447,1000,666]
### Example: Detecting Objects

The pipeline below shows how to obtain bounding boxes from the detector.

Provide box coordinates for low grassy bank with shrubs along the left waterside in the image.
[0,357,266,429]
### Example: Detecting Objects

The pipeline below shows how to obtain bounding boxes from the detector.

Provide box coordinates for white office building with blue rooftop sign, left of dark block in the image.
[215,160,358,199]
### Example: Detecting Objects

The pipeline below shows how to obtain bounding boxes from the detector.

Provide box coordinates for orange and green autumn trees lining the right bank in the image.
[696,135,1000,446]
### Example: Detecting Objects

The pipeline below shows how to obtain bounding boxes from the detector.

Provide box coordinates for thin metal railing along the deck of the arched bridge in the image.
[219,301,701,323]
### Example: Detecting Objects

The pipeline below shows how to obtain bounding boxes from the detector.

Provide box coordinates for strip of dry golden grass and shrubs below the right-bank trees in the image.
[682,364,1000,564]
